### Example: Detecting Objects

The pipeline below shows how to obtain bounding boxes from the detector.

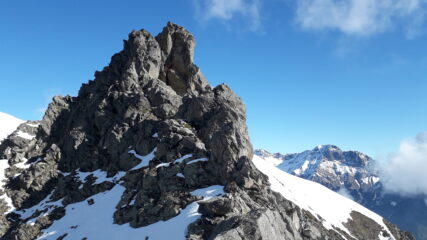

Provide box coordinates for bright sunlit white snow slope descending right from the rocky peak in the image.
[252,155,392,239]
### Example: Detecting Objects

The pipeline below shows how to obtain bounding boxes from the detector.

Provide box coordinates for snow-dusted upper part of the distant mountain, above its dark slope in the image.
[255,145,379,196]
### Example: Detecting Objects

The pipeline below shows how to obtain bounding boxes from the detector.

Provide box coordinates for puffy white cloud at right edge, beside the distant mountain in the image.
[381,132,427,195]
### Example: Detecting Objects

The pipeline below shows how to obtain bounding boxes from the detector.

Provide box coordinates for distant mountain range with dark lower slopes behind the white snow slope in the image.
[255,145,427,239]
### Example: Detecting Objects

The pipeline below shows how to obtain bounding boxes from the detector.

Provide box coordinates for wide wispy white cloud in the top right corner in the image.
[296,0,427,38]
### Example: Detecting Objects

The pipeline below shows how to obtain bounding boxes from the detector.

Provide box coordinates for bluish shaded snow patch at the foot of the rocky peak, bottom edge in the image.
[38,184,224,240]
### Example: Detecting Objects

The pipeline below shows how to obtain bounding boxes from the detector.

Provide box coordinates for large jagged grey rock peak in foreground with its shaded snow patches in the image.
[0,23,413,240]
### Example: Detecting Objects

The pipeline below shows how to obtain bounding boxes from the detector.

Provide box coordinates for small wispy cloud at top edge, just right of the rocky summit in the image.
[193,0,261,31]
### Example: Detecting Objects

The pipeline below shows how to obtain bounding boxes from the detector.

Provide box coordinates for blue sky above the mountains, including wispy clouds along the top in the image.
[0,0,427,157]
